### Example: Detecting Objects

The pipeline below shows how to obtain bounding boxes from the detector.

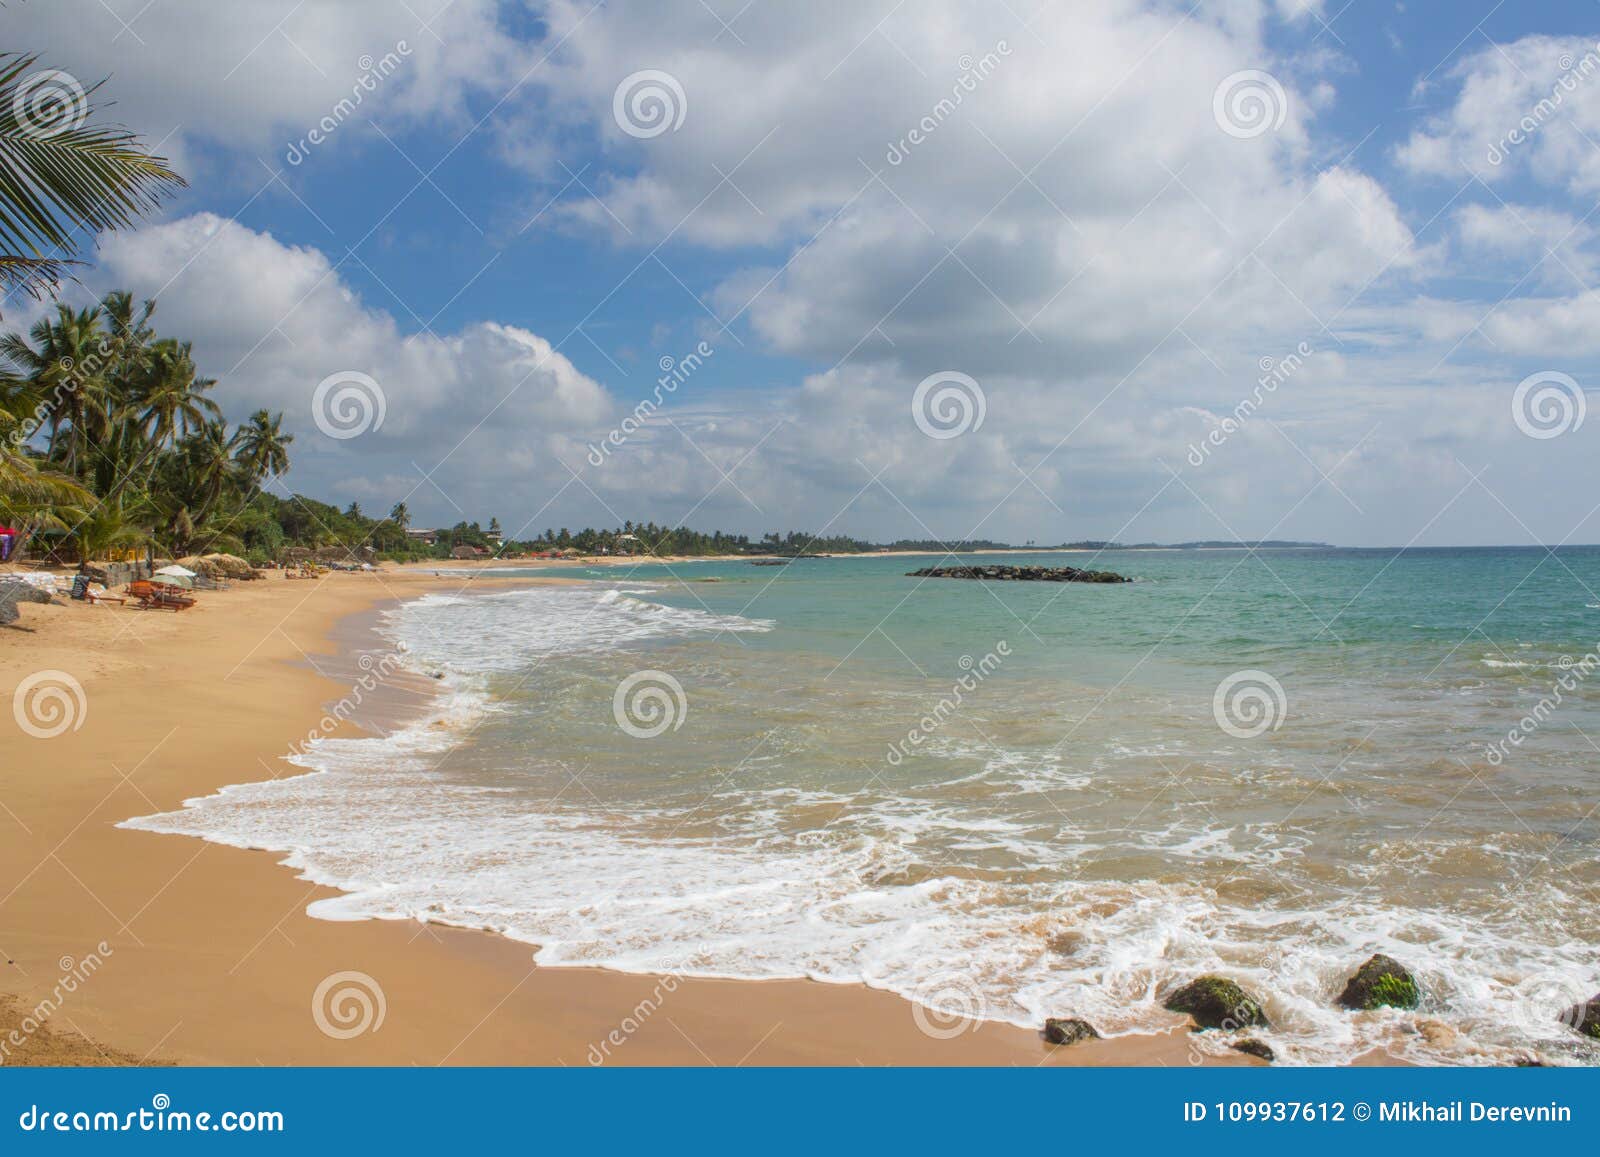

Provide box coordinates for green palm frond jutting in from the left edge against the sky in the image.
[0,53,184,312]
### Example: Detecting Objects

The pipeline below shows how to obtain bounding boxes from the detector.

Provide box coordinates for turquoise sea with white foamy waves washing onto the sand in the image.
[124,547,1600,1064]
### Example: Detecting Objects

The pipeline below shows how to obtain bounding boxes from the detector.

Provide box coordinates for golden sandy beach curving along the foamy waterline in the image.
[0,563,1235,1066]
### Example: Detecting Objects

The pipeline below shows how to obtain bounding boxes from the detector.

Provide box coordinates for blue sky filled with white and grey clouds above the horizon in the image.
[9,0,1600,546]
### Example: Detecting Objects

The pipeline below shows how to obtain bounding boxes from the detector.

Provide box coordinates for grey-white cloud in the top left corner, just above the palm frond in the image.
[6,0,538,162]
